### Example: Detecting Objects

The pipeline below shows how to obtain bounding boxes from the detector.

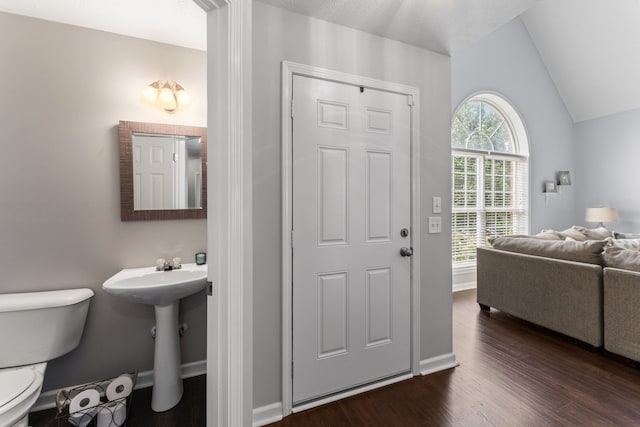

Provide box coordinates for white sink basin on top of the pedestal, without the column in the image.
[102,264,207,306]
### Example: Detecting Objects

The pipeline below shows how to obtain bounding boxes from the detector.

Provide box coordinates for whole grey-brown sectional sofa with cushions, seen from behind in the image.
[477,229,640,361]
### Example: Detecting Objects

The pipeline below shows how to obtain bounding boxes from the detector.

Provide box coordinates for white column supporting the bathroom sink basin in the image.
[151,301,183,412]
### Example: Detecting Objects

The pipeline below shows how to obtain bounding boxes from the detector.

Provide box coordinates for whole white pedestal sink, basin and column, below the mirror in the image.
[102,264,207,412]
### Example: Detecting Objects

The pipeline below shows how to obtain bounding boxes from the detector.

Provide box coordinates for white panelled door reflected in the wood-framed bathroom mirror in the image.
[133,135,174,210]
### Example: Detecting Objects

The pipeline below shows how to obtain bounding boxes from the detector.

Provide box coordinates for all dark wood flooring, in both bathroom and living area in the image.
[31,290,640,427]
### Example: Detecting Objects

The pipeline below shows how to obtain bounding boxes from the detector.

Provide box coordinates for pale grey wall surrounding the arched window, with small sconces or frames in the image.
[451,18,578,233]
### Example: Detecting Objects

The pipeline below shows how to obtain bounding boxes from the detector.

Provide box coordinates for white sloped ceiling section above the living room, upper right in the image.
[522,0,640,122]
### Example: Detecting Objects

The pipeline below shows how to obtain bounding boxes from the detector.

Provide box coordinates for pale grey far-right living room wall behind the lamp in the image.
[574,110,640,232]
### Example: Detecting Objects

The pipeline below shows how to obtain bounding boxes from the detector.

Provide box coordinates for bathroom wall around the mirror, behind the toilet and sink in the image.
[0,13,206,390]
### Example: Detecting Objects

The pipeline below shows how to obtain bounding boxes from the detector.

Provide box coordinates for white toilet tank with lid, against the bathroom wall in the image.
[0,288,93,368]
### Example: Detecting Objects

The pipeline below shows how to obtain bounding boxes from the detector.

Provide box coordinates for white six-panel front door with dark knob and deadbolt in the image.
[292,76,411,404]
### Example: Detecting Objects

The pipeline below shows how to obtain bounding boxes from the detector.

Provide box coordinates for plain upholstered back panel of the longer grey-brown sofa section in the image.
[477,248,604,347]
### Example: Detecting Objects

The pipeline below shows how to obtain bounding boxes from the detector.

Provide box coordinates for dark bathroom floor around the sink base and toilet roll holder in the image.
[29,375,207,427]
